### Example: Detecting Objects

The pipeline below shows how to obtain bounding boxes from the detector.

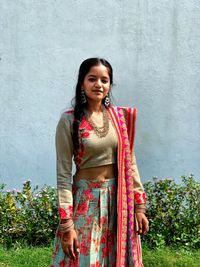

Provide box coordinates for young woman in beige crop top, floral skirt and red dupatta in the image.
[51,58,148,267]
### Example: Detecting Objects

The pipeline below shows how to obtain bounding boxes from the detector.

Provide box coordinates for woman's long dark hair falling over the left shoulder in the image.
[72,58,113,152]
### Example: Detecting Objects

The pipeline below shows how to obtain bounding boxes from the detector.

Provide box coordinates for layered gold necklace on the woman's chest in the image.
[86,108,109,138]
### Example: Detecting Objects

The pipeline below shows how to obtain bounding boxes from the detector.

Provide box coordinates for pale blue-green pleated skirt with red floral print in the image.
[51,178,117,267]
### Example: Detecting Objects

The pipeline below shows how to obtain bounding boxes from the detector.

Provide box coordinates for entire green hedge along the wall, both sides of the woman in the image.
[0,175,200,249]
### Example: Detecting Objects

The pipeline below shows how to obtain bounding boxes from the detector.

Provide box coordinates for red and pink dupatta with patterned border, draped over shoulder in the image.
[108,107,143,267]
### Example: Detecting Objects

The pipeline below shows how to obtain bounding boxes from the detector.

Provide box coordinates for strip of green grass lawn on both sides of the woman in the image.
[0,248,200,267]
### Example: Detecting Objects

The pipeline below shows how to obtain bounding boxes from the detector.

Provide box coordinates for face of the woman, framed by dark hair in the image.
[82,64,110,102]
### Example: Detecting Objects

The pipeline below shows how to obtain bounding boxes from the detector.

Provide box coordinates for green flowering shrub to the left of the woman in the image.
[0,181,58,247]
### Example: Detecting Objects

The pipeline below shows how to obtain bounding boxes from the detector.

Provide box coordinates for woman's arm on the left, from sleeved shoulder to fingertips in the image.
[56,114,79,260]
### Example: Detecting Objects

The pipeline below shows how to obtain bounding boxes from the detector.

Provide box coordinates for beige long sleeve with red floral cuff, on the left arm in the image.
[56,114,73,219]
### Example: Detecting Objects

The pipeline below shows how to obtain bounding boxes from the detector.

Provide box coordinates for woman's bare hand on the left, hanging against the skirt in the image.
[61,230,79,261]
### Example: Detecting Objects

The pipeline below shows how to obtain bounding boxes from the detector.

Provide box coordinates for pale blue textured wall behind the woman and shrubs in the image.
[0,0,200,187]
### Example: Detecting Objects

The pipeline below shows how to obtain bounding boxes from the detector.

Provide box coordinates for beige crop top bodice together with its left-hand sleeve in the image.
[56,110,118,221]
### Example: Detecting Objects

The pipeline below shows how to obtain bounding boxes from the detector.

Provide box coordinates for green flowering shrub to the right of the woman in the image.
[143,175,200,249]
